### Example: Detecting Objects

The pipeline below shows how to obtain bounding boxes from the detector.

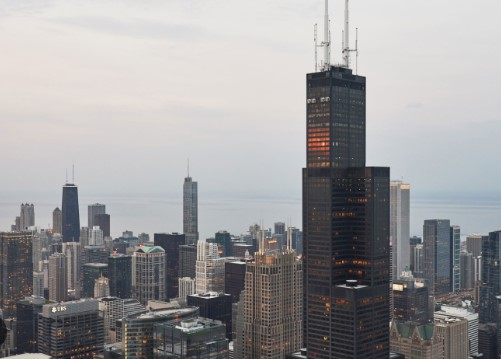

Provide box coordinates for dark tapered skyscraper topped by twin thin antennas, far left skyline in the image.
[62,183,80,242]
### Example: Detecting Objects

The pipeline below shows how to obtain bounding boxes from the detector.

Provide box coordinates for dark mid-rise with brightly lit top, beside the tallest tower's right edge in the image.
[392,271,433,324]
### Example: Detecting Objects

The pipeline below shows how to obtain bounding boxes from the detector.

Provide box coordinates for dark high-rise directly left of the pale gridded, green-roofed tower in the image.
[108,254,132,299]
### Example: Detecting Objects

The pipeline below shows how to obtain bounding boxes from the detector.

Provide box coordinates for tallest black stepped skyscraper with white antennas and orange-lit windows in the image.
[303,0,390,359]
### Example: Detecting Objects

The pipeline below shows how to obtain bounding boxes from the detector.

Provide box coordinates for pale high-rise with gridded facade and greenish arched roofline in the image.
[132,246,166,305]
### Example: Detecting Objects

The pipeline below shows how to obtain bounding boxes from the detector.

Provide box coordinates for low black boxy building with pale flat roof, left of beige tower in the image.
[187,293,232,341]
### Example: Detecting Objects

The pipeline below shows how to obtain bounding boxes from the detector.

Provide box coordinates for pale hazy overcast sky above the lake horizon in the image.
[0,0,501,238]
